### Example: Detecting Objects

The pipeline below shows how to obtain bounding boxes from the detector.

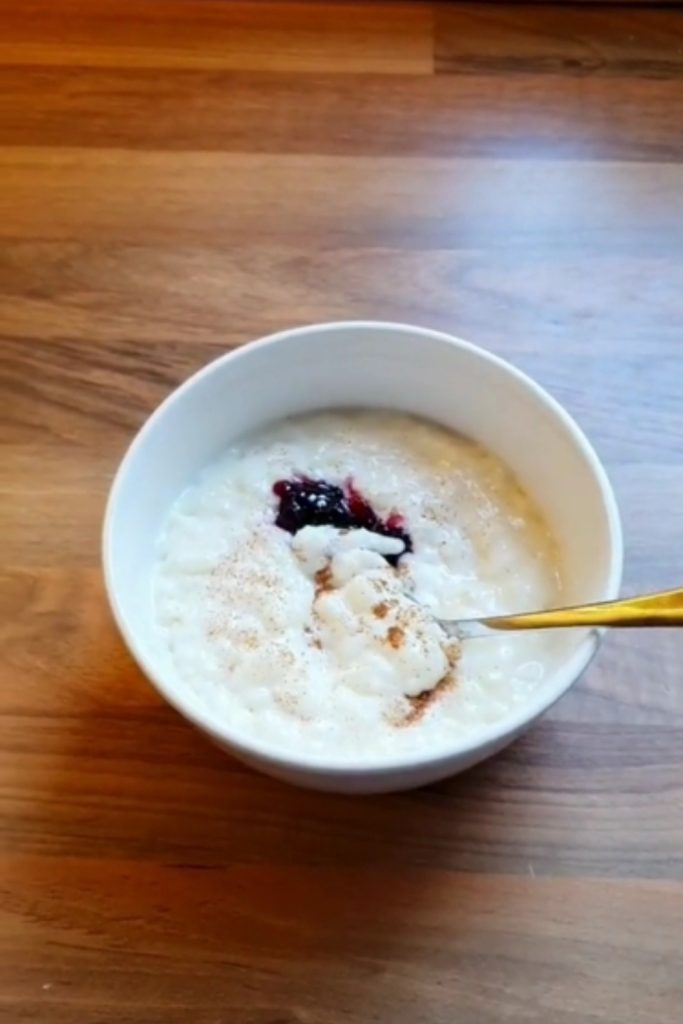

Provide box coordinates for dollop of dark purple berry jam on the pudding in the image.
[272,476,413,565]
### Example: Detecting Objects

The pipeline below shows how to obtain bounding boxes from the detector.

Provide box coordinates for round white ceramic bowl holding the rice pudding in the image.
[103,322,622,793]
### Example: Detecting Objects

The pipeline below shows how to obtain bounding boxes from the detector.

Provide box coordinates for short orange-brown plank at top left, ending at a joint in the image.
[0,0,433,75]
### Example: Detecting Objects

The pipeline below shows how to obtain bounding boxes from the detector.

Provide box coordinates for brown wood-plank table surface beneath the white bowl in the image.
[0,0,683,1024]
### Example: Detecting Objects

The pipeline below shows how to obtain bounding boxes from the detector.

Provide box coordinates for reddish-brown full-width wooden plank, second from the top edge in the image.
[0,64,683,160]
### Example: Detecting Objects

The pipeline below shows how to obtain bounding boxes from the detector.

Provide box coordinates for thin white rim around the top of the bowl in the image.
[101,321,624,779]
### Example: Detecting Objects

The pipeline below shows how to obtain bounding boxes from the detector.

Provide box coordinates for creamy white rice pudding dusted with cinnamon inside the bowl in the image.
[153,412,561,762]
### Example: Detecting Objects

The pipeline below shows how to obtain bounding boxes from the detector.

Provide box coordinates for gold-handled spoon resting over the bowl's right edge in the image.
[437,590,683,640]
